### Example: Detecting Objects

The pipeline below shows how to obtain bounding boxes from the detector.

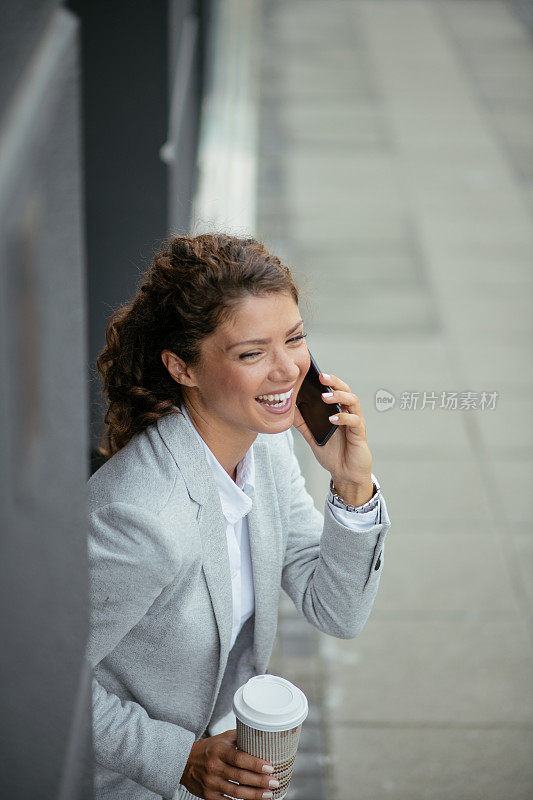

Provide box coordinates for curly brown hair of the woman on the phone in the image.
[96,233,300,458]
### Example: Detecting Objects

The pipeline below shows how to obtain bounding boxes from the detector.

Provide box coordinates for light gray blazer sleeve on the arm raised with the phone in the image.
[281,430,390,639]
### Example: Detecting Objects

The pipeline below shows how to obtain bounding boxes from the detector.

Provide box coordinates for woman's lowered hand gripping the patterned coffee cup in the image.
[181,728,274,800]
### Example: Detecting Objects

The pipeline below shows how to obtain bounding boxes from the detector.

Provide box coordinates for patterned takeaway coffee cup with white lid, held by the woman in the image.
[233,675,309,800]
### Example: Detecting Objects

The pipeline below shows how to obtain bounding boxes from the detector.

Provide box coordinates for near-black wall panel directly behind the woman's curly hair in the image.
[69,0,168,454]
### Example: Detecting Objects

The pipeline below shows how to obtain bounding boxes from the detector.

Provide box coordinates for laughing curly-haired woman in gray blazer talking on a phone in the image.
[88,234,390,800]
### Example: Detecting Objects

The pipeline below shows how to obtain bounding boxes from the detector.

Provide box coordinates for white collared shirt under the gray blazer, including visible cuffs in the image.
[181,405,379,736]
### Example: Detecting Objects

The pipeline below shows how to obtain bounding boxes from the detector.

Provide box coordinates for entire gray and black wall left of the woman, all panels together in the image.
[0,0,211,800]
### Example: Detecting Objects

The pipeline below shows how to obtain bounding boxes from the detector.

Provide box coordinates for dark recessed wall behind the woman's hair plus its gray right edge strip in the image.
[64,0,210,462]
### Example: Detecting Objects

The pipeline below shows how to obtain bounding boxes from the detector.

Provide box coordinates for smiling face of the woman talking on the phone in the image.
[167,293,310,448]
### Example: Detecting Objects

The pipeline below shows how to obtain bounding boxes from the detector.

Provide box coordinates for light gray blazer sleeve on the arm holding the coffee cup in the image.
[87,503,196,798]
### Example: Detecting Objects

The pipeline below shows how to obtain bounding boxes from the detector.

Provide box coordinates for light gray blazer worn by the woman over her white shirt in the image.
[88,411,390,800]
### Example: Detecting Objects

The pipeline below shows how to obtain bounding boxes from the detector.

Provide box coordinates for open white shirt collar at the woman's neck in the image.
[181,405,255,525]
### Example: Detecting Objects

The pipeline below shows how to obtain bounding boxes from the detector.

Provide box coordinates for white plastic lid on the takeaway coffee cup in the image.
[233,674,309,731]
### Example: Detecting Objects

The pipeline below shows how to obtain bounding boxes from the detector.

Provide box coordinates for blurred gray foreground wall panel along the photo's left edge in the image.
[0,2,92,800]
